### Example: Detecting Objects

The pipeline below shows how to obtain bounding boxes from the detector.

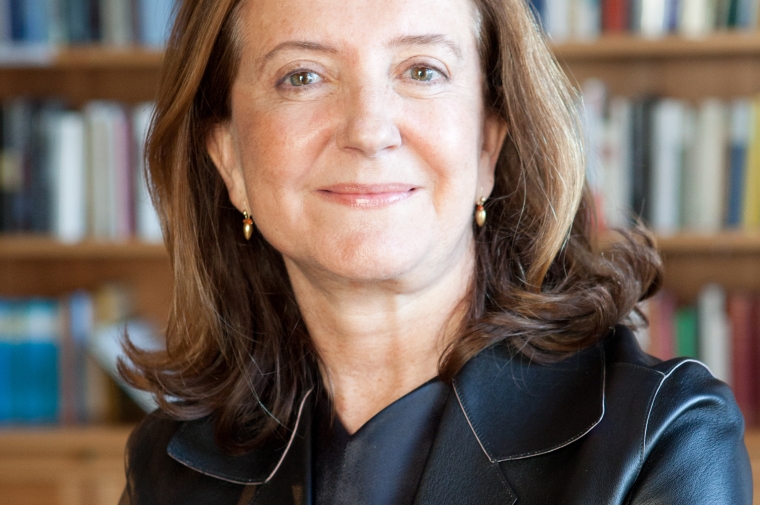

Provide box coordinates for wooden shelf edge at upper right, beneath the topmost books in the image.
[551,32,760,62]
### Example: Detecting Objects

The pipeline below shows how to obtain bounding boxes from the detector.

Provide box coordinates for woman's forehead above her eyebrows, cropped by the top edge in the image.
[239,0,477,52]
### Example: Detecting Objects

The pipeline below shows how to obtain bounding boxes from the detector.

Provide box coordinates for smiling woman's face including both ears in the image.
[208,0,505,281]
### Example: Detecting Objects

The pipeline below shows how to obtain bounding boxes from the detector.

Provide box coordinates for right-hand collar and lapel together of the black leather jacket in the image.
[414,345,605,505]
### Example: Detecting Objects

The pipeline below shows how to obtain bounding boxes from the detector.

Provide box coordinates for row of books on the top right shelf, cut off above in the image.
[531,0,760,42]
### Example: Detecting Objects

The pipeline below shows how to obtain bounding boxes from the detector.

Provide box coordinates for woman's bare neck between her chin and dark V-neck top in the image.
[286,240,474,433]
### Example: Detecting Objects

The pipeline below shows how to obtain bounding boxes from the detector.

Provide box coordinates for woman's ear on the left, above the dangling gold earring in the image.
[206,122,251,213]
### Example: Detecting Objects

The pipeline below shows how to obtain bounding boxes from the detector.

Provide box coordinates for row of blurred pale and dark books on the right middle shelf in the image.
[583,80,760,235]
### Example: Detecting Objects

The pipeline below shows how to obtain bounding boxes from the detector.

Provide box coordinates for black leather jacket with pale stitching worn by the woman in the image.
[122,327,752,505]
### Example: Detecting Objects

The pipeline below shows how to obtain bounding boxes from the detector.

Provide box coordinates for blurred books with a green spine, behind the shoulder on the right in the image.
[640,284,760,425]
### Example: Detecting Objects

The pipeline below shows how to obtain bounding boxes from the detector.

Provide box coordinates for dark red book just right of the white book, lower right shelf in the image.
[727,293,758,425]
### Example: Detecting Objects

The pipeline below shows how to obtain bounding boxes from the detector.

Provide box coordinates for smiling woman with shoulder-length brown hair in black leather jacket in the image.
[122,0,751,505]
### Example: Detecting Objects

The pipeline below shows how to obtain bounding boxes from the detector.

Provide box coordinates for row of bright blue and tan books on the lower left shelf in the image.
[0,285,155,426]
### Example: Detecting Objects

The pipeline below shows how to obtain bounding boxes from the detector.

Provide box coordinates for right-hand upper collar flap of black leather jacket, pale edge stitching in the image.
[454,338,605,462]
